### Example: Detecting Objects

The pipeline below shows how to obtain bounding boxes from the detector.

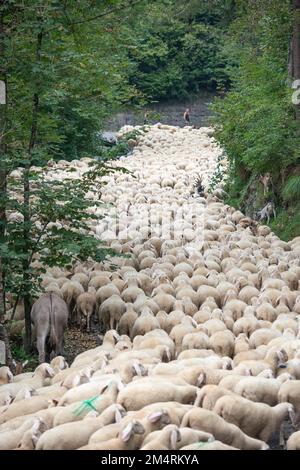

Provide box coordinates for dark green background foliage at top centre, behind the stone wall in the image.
[126,0,229,100]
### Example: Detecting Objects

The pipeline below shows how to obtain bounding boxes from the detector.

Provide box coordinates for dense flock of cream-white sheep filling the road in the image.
[0,124,300,450]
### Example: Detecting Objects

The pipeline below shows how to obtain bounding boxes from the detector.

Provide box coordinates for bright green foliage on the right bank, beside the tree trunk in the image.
[213,0,300,237]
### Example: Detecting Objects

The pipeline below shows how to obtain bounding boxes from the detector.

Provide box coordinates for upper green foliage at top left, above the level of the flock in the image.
[1,0,143,160]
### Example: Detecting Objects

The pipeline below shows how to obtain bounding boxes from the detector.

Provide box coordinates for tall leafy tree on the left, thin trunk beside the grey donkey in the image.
[0,0,145,351]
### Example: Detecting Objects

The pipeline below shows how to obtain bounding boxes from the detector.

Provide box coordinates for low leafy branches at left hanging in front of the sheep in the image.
[0,162,122,297]
